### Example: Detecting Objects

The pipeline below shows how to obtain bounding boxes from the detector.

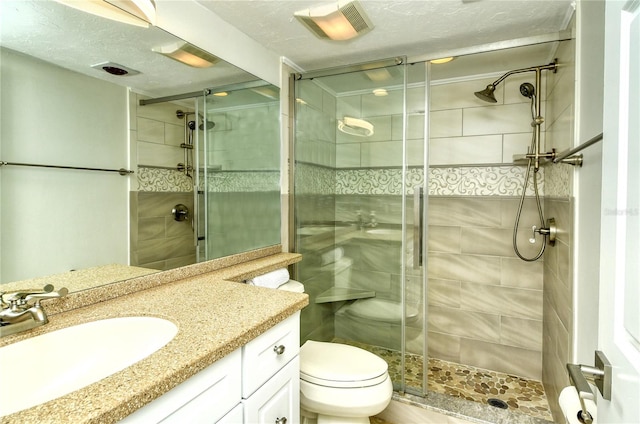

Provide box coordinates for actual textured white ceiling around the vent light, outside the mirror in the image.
[198,0,573,70]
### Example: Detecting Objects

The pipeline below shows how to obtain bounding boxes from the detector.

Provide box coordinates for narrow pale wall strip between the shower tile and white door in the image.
[573,1,605,364]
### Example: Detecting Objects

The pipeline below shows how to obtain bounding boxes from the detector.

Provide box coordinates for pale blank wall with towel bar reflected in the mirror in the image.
[0,50,130,282]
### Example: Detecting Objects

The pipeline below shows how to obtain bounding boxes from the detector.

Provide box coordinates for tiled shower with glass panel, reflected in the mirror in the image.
[132,81,281,269]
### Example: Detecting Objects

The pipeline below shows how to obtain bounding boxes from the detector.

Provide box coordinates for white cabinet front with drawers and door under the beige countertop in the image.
[121,312,300,424]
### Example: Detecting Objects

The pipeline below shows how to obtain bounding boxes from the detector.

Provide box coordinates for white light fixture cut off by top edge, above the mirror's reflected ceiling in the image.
[56,0,156,28]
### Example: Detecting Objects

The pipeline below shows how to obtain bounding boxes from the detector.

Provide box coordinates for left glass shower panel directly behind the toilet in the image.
[293,60,426,394]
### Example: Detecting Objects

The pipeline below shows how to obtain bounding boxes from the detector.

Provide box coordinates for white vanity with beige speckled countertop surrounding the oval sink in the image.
[0,253,308,424]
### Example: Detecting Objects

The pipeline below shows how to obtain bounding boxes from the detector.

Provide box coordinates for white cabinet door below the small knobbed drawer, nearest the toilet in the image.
[242,356,300,424]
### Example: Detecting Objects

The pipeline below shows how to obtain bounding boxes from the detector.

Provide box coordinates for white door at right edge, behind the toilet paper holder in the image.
[600,0,640,423]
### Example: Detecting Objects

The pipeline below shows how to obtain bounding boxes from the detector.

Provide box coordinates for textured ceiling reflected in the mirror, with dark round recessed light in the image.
[0,0,257,96]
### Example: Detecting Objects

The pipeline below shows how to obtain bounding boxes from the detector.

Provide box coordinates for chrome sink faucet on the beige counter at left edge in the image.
[0,284,69,337]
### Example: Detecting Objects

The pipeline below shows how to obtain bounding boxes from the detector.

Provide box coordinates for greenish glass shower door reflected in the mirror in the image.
[197,81,281,260]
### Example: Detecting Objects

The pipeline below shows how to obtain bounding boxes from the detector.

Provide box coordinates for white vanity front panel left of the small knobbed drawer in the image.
[121,349,242,424]
